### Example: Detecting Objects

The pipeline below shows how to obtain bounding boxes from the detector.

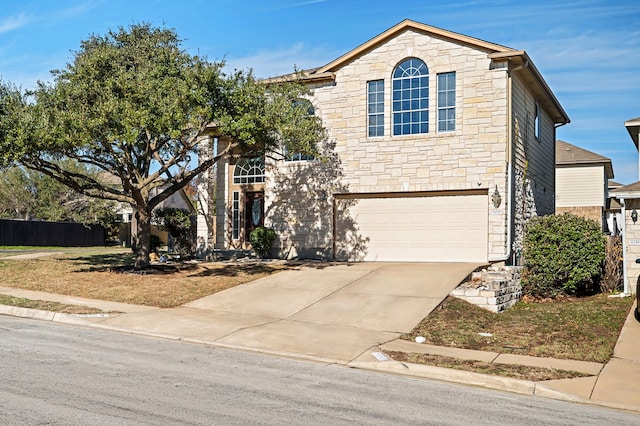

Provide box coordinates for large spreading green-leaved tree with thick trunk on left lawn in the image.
[0,24,324,267]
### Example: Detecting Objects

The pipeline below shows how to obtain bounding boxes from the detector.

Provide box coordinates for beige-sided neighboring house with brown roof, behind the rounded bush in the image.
[556,140,614,231]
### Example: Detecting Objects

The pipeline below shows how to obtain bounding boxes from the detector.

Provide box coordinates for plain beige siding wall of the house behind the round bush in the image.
[556,165,605,208]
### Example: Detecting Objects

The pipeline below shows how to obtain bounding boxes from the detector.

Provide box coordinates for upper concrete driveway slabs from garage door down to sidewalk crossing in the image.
[185,263,479,333]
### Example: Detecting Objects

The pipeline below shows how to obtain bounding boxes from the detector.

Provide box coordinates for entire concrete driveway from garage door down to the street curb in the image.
[103,263,481,362]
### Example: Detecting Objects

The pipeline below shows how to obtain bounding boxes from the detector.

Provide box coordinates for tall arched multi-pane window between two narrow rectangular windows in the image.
[392,58,429,135]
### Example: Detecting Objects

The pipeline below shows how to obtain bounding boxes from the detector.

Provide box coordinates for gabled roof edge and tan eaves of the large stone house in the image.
[265,19,571,124]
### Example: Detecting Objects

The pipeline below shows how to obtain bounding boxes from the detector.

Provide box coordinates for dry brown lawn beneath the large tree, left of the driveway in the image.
[0,247,292,308]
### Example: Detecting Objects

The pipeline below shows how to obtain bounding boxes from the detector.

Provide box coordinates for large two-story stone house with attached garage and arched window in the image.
[201,20,569,263]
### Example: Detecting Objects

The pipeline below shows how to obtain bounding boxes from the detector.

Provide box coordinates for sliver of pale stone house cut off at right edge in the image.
[614,118,640,293]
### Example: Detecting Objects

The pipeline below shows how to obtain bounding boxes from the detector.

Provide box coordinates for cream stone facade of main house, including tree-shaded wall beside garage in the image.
[202,21,568,261]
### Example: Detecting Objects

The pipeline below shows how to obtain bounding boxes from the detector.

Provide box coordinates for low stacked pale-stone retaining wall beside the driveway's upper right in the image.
[451,266,522,313]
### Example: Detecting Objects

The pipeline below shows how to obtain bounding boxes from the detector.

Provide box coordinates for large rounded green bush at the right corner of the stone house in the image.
[523,214,605,296]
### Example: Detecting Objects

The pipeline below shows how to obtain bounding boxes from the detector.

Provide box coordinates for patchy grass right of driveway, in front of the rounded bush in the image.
[402,294,633,363]
